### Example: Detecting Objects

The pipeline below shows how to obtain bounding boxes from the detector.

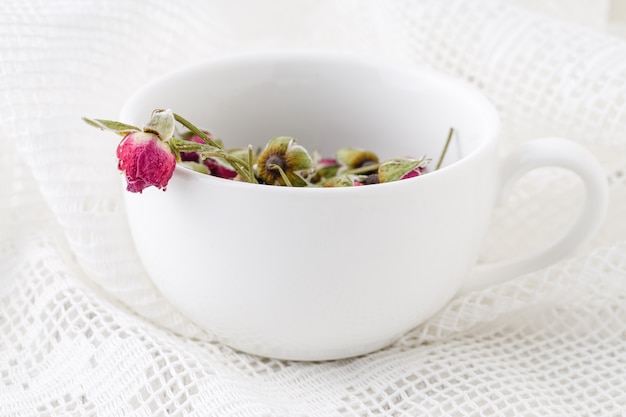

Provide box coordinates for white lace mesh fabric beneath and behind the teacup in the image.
[0,0,626,416]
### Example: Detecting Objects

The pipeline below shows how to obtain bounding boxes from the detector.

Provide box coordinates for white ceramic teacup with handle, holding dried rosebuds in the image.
[121,53,607,360]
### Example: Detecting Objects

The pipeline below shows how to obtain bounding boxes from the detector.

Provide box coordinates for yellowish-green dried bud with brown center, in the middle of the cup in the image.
[256,136,313,187]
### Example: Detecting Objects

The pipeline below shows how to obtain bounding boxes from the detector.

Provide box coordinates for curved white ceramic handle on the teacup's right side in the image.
[460,138,609,293]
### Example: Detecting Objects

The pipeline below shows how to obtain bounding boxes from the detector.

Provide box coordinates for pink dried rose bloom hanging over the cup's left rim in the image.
[117,132,176,193]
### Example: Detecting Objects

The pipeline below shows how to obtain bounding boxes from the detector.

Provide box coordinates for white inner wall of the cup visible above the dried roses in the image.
[120,53,498,169]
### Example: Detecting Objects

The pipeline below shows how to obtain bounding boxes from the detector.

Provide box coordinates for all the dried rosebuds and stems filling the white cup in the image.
[83,109,453,193]
